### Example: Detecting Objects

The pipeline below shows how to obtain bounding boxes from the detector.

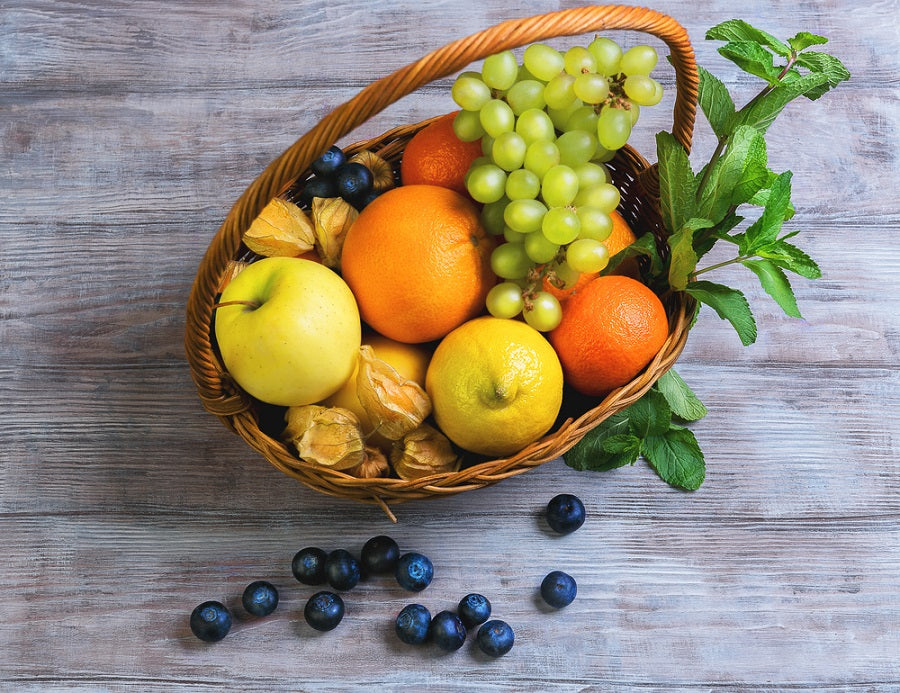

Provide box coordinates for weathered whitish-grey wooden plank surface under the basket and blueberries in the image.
[0,0,900,692]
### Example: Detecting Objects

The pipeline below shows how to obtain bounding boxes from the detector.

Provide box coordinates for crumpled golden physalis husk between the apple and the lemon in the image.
[356,344,431,440]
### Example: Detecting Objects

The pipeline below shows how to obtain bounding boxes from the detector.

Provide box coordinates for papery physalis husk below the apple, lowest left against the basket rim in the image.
[282,404,366,469]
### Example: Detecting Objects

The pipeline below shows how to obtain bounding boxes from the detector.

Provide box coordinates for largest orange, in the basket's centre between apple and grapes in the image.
[341,185,496,343]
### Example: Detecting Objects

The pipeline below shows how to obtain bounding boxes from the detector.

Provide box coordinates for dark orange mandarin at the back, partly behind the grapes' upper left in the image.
[400,112,482,195]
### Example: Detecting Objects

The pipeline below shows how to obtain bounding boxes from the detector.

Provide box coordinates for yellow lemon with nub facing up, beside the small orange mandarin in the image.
[425,316,563,455]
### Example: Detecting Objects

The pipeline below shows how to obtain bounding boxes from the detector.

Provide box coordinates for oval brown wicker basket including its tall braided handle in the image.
[185,5,697,519]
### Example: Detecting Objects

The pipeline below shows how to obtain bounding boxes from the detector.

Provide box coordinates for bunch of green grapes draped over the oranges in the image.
[451,37,663,332]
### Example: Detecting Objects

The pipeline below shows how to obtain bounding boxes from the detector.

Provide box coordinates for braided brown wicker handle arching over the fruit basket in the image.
[186,5,698,416]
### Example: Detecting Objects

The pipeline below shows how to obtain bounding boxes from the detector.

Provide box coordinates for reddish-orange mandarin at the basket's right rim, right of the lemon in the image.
[549,276,669,395]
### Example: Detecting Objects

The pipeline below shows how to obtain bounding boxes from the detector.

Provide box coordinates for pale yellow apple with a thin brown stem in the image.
[215,257,361,407]
